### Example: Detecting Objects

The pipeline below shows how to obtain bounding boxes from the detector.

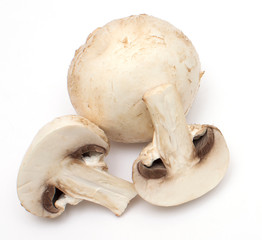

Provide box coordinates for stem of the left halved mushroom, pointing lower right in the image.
[55,159,136,216]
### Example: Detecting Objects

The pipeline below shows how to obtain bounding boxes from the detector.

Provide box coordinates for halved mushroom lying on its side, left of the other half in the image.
[17,116,136,218]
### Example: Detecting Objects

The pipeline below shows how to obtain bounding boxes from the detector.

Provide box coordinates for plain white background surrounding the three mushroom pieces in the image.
[0,0,262,240]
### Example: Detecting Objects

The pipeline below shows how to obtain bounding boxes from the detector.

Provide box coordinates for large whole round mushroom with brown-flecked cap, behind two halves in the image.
[68,14,203,143]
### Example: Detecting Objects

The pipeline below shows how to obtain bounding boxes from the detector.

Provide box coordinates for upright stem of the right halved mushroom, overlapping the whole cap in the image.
[143,84,194,169]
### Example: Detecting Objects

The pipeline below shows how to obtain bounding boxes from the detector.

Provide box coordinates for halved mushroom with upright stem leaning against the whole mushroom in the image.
[133,84,229,206]
